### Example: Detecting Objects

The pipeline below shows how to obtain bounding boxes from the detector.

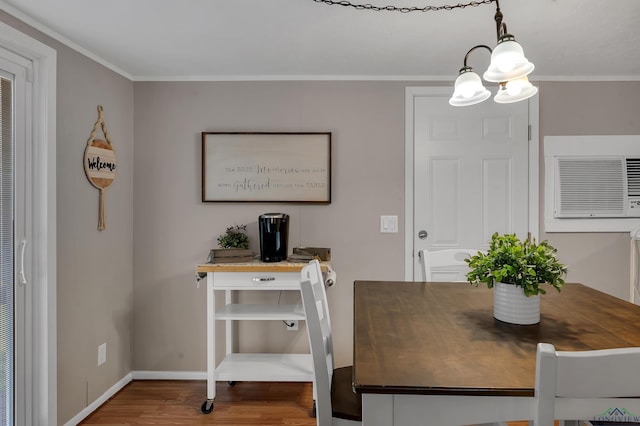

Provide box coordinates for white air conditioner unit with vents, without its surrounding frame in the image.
[554,155,640,218]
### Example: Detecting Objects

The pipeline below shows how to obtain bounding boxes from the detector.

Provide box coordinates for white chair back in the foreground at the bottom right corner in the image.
[533,342,640,426]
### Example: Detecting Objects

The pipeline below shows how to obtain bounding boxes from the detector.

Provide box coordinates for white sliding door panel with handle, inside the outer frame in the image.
[0,48,31,425]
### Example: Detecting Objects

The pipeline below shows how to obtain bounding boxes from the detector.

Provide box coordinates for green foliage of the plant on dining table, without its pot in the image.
[465,232,567,296]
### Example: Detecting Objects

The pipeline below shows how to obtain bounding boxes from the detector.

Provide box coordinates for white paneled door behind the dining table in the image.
[407,89,538,280]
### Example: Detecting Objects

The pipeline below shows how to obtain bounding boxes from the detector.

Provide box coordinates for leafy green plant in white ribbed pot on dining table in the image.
[465,232,567,324]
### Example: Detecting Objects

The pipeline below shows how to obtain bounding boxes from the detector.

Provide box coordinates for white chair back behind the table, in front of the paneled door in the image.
[418,248,478,282]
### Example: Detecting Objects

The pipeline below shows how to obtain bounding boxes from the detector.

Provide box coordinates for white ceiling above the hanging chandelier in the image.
[0,0,640,81]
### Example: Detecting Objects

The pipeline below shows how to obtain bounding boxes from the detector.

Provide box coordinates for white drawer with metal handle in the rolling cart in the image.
[213,272,300,290]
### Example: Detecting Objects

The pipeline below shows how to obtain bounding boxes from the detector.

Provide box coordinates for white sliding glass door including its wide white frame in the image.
[0,23,57,426]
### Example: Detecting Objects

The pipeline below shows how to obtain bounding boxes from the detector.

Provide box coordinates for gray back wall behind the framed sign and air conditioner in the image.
[133,82,640,376]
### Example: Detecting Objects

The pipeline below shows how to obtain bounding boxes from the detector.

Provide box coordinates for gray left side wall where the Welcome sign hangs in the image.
[0,12,133,424]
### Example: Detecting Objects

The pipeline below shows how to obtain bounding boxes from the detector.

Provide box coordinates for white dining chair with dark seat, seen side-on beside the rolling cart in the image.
[300,260,362,426]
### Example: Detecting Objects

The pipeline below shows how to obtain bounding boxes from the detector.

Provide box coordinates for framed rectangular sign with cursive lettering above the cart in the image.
[202,132,331,204]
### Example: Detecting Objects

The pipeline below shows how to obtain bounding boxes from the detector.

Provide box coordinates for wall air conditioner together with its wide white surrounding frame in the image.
[544,135,640,232]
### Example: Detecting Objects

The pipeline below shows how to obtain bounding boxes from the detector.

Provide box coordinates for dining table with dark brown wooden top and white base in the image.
[353,281,640,426]
